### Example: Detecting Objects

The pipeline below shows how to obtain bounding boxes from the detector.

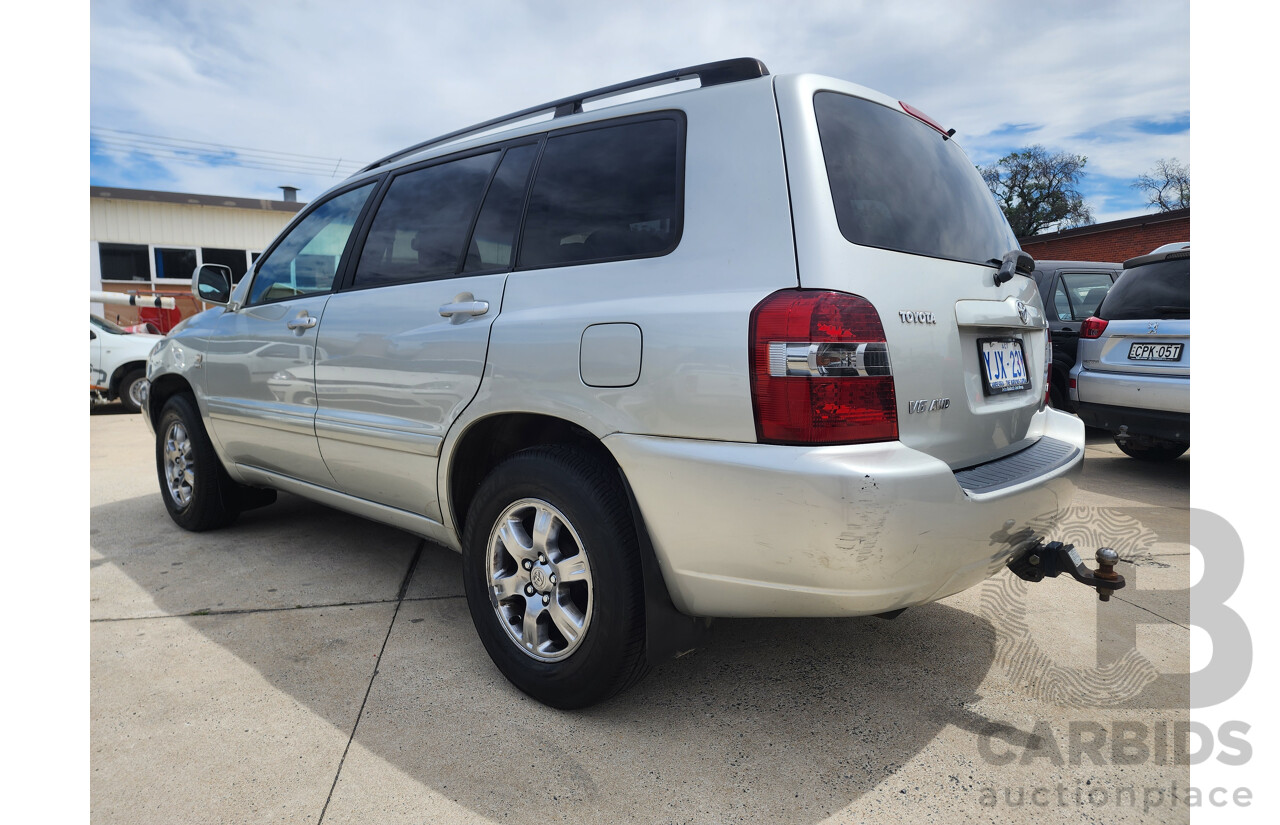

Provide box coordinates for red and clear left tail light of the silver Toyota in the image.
[750,289,897,444]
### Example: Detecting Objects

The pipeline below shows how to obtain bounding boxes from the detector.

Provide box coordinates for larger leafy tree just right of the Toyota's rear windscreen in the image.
[978,146,1093,238]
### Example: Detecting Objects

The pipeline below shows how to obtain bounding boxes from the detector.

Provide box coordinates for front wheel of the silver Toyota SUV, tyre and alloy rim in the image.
[156,394,241,532]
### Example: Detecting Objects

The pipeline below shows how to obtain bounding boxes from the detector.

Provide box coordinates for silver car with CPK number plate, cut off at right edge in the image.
[1070,243,1192,460]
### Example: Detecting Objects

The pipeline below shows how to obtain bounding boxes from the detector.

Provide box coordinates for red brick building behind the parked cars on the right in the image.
[1018,207,1192,262]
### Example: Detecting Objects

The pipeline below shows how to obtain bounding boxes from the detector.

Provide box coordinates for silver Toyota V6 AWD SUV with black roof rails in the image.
[147,59,1084,707]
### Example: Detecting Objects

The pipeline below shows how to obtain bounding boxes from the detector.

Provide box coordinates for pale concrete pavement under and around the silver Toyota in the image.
[90,408,1190,825]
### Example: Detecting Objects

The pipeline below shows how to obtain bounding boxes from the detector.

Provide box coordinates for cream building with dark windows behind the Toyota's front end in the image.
[90,187,305,322]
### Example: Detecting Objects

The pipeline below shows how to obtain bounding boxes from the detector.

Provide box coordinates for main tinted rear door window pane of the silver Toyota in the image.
[353,152,498,287]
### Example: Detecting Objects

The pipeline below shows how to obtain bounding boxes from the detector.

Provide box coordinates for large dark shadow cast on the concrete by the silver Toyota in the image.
[90,495,998,822]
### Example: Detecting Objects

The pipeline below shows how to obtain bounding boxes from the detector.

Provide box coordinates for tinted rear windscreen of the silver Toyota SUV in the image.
[813,92,1018,263]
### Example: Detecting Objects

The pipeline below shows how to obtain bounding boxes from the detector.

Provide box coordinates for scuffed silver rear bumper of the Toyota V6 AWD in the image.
[604,409,1084,617]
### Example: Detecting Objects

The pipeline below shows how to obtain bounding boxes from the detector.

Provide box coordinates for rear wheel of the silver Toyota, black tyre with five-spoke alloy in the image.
[462,446,646,709]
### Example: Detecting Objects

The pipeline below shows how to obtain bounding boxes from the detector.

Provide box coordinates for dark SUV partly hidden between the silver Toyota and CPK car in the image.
[1032,261,1120,412]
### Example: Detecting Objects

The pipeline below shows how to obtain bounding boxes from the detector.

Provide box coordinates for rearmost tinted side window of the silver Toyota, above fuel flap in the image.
[517,118,682,269]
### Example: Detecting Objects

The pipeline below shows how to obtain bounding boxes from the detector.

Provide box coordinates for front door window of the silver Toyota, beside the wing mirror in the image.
[248,183,374,303]
